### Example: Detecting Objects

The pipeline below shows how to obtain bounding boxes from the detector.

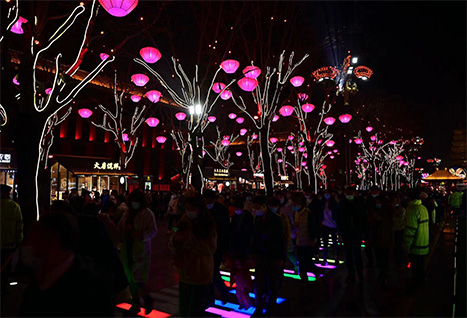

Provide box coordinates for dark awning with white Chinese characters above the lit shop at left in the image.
[53,155,135,176]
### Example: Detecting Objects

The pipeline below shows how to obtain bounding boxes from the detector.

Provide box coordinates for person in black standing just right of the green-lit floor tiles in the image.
[337,187,367,282]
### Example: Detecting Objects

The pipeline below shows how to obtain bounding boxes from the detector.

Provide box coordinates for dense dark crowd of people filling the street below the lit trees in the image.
[1,186,465,317]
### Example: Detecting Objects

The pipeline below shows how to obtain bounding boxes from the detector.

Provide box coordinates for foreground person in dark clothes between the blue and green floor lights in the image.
[252,196,287,316]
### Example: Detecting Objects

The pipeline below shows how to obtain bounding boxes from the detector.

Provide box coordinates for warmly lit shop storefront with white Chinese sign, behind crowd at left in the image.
[50,155,138,201]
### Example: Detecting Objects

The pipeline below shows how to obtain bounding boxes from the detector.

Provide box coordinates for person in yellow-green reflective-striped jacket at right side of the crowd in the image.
[403,189,430,292]
